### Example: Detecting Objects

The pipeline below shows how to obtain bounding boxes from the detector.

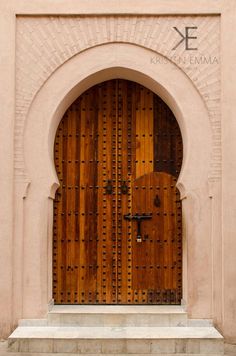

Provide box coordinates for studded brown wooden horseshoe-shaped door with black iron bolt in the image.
[53,79,182,304]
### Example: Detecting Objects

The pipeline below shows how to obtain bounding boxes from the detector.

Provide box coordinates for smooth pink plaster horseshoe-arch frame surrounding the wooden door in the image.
[15,43,219,318]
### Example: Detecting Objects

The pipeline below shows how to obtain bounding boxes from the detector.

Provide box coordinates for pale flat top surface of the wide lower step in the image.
[9,326,223,340]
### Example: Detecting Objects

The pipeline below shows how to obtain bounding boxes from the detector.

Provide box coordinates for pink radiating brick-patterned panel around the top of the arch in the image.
[15,16,221,180]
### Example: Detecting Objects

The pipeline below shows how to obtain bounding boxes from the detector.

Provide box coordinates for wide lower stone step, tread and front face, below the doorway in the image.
[8,326,223,355]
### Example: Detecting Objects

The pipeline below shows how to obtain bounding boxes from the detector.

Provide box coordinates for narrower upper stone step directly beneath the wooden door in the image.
[45,305,187,326]
